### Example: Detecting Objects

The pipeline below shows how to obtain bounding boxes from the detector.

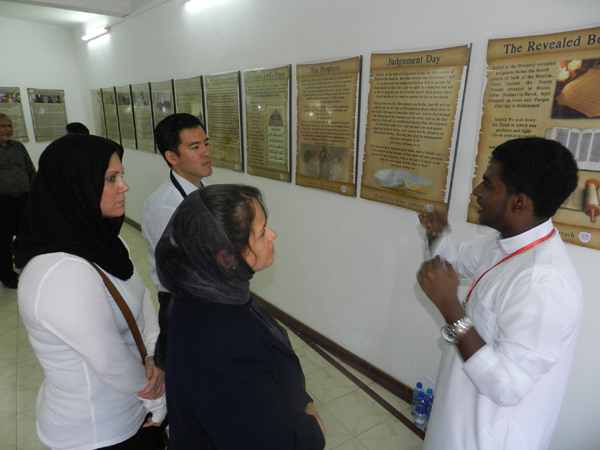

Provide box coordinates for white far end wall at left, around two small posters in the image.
[0,17,84,167]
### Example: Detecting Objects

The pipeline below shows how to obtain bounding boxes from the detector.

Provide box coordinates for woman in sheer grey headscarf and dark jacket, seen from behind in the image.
[156,185,325,450]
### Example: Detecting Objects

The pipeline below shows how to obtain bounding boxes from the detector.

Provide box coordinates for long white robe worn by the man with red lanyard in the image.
[423,220,583,450]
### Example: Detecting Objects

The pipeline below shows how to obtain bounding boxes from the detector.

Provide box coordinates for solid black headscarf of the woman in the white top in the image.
[13,135,133,280]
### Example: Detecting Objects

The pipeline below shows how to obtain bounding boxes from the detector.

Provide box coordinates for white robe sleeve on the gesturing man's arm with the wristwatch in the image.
[463,272,578,406]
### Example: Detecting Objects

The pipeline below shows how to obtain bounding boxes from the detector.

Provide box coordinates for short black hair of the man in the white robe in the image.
[492,137,578,218]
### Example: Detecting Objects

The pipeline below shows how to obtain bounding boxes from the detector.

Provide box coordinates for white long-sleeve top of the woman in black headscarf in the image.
[18,253,166,450]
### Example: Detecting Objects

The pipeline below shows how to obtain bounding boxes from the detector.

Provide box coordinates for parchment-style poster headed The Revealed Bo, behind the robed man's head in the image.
[476,28,600,249]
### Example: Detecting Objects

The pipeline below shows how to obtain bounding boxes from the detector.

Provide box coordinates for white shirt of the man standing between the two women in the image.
[142,172,198,291]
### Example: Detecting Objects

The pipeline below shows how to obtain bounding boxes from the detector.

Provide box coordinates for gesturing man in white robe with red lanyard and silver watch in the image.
[417,138,583,450]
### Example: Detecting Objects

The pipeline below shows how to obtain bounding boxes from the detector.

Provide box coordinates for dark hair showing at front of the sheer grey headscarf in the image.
[198,184,268,255]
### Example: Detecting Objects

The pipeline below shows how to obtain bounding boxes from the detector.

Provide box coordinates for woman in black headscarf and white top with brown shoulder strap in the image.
[15,135,166,449]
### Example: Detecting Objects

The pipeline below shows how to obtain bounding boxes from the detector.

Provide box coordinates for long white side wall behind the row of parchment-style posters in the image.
[9,0,600,450]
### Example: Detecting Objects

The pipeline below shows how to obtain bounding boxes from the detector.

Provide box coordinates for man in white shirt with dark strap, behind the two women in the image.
[142,113,212,369]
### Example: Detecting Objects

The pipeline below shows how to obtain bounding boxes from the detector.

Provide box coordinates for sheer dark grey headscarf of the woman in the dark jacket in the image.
[155,190,291,349]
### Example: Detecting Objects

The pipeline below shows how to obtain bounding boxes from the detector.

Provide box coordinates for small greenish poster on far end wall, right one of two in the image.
[27,88,67,141]
